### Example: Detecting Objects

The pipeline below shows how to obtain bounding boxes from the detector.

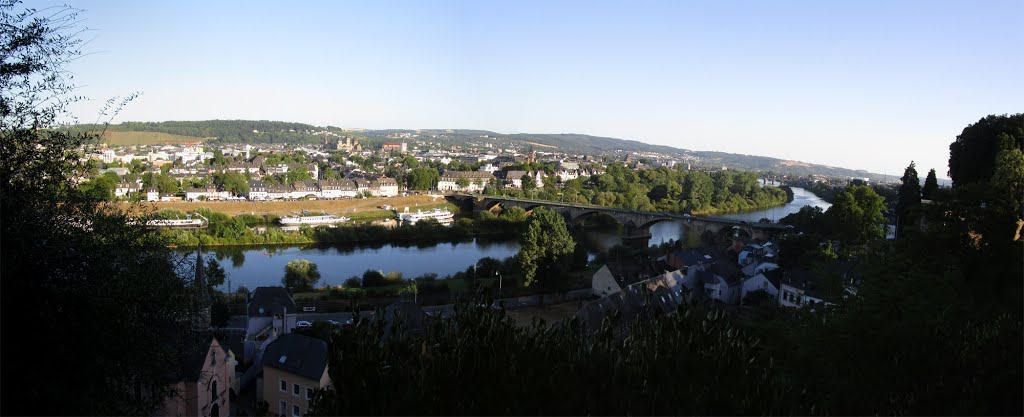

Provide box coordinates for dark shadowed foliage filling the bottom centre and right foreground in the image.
[314,182,1024,415]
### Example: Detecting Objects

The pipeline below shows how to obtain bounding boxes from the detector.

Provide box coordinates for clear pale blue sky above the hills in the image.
[33,0,1024,177]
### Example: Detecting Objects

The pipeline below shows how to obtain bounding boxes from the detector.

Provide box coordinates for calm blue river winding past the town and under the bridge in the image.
[201,187,830,290]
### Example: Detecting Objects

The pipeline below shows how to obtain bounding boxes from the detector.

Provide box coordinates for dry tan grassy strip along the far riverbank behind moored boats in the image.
[121,196,446,219]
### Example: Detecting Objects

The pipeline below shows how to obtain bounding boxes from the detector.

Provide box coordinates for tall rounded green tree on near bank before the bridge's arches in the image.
[516,207,575,286]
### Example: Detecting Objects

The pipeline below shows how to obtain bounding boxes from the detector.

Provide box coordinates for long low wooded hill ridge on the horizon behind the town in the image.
[74,120,893,181]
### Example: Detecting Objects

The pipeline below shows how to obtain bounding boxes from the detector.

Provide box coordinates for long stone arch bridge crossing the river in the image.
[445,194,793,246]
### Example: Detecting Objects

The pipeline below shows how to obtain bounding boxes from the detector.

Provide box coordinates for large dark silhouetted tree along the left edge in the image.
[0,1,198,415]
